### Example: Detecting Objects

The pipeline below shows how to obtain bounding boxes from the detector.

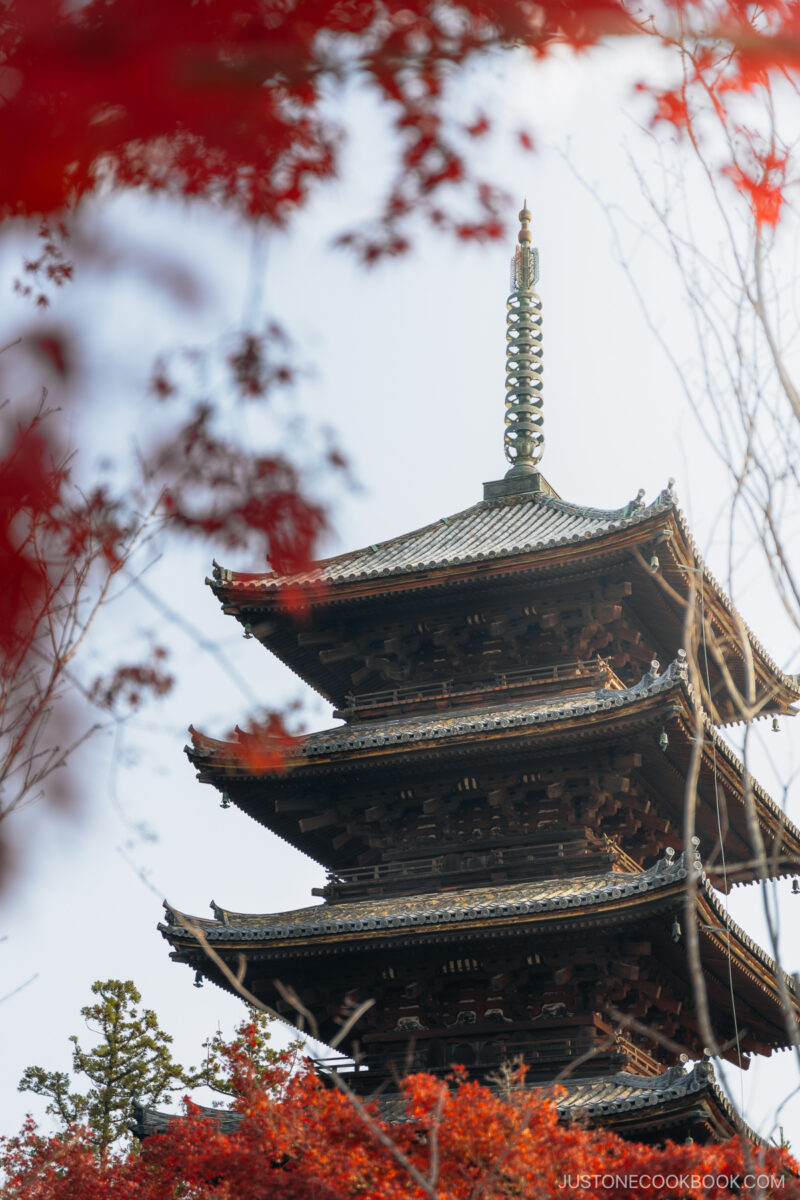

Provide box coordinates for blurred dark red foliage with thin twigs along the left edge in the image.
[0,408,140,887]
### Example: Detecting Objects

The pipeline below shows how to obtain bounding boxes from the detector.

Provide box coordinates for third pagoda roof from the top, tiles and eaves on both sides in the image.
[160,853,800,1054]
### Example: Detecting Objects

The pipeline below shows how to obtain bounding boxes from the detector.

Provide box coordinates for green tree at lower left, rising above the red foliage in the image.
[18,979,203,1158]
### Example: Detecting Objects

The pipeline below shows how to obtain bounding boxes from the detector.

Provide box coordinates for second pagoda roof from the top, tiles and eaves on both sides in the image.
[186,655,800,887]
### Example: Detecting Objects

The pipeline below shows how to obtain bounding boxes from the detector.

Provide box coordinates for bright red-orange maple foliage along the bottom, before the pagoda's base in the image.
[0,1026,800,1200]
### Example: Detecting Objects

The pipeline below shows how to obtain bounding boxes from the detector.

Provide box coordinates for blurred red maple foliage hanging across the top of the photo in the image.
[0,0,800,265]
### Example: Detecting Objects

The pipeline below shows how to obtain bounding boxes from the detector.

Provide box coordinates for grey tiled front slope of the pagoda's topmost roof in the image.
[209,491,675,590]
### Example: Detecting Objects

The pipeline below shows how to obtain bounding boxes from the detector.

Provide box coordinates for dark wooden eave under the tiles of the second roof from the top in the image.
[190,688,800,890]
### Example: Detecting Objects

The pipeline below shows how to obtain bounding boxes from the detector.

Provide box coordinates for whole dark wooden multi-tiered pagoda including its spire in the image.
[160,208,800,1141]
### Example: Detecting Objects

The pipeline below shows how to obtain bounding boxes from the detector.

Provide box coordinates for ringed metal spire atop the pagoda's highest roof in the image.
[504,199,545,479]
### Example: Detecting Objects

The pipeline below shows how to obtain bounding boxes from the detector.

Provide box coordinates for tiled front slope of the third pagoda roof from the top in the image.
[160,854,686,941]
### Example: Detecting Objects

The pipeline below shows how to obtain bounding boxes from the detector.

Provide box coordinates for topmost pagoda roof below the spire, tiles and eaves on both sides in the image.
[206,488,800,722]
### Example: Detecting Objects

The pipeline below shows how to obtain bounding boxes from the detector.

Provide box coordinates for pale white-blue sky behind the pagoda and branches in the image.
[0,35,800,1144]
